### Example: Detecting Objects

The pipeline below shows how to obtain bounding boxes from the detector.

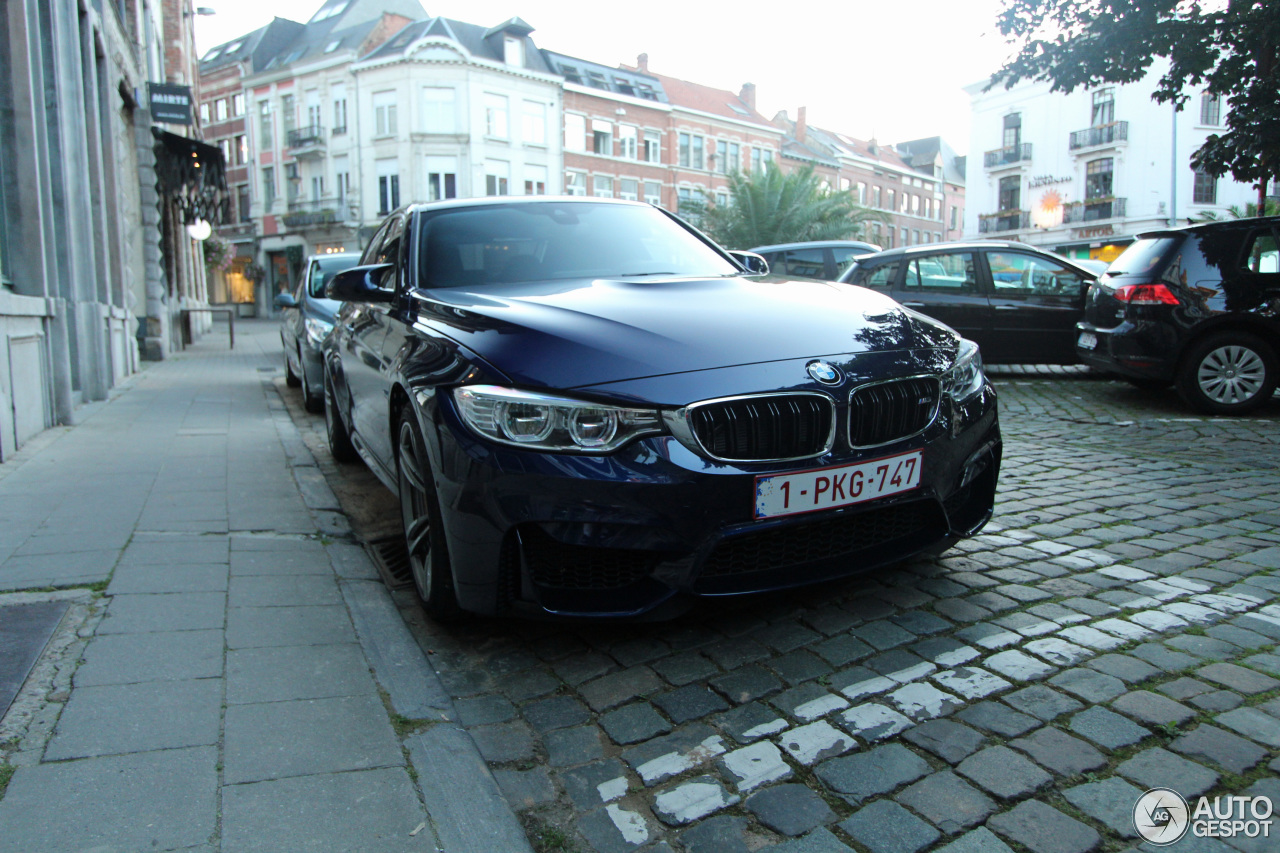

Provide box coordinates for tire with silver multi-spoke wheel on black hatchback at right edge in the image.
[1178,332,1276,415]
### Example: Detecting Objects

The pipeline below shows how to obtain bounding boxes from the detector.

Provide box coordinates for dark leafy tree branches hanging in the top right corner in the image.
[988,0,1280,207]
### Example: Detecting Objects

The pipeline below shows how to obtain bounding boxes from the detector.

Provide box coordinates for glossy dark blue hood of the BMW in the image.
[415,277,956,388]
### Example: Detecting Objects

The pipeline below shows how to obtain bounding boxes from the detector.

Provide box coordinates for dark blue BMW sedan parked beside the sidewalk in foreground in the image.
[324,197,1001,616]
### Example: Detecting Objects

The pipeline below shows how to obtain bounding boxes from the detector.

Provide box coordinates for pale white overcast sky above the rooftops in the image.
[195,0,1011,154]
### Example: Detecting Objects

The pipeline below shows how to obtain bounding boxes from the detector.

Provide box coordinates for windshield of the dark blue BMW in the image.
[421,201,740,287]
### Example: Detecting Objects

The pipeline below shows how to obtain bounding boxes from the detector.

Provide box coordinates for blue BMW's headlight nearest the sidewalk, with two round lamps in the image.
[453,386,664,453]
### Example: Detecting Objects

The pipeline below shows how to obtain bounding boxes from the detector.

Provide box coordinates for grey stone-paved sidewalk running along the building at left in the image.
[0,321,529,853]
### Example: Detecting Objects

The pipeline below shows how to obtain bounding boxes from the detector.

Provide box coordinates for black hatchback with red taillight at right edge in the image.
[1076,216,1280,415]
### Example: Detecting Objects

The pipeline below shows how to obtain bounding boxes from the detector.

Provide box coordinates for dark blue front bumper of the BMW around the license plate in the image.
[435,384,1001,616]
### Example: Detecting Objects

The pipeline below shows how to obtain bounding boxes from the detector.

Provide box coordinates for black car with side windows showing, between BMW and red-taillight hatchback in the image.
[837,241,1097,364]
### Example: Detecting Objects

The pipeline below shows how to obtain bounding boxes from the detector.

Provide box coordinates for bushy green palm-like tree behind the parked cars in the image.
[681,163,884,248]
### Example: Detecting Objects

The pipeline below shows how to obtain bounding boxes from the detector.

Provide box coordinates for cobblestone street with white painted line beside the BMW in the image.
[287,370,1280,853]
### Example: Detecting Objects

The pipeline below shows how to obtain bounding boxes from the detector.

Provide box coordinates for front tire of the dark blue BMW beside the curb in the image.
[396,406,461,621]
